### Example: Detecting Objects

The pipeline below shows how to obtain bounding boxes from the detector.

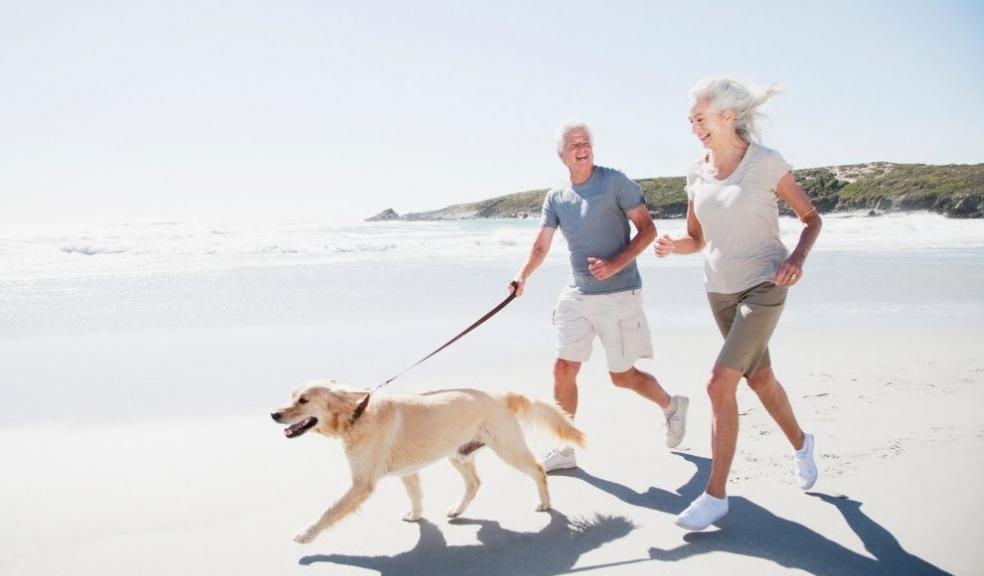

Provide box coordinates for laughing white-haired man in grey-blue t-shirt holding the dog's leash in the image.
[514,121,688,471]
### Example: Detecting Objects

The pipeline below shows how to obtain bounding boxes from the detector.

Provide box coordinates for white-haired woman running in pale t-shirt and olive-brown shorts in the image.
[655,78,821,530]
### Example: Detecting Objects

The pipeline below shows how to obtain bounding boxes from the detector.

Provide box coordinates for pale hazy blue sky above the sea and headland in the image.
[0,0,984,225]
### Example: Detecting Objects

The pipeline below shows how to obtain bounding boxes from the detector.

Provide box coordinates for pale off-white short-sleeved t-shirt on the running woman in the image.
[687,144,792,294]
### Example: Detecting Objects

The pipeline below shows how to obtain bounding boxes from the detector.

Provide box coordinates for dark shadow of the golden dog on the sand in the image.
[300,510,635,576]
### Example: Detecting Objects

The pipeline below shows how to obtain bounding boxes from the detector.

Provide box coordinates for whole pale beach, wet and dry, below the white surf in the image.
[0,214,984,576]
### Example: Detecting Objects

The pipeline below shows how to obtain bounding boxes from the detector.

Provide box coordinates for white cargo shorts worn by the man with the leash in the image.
[553,288,653,373]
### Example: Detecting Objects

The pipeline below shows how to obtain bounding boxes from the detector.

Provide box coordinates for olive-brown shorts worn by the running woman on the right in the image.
[707,282,787,377]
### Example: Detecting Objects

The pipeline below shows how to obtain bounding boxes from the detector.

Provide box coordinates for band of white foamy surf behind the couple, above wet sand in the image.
[0,213,984,282]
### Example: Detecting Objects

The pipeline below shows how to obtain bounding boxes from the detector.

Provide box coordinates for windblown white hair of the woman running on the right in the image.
[690,76,783,143]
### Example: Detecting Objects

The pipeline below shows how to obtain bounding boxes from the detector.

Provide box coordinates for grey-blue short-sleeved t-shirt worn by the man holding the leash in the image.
[540,166,644,294]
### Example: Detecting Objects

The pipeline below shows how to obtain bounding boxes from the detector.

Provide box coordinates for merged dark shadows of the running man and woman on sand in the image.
[567,453,948,576]
